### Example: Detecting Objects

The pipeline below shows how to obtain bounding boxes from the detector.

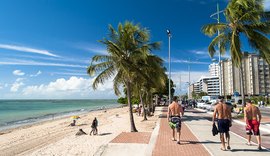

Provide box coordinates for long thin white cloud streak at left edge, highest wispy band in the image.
[0,44,58,57]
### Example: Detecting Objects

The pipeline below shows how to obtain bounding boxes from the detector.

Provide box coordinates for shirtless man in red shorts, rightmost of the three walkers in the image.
[244,99,262,150]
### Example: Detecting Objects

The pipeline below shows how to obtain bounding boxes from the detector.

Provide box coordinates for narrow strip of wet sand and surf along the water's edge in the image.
[0,104,121,133]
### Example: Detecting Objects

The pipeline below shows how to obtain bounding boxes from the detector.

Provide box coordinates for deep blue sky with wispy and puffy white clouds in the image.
[0,0,270,99]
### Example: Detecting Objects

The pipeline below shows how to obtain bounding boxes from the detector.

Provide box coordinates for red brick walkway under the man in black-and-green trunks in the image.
[152,108,210,156]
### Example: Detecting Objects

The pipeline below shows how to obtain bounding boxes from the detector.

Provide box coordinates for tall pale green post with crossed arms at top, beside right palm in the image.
[210,4,224,96]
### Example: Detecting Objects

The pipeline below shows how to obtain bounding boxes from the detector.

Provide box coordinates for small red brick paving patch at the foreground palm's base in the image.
[111,132,151,144]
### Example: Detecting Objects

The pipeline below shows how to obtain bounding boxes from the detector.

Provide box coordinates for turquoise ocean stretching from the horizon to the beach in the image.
[0,99,120,130]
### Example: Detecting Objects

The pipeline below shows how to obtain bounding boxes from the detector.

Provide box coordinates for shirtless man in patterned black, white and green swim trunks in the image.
[167,96,184,144]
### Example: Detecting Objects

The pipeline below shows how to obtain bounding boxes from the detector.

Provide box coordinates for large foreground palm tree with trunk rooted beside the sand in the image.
[87,22,160,132]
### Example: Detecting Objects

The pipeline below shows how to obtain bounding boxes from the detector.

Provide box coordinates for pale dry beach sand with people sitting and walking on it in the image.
[0,107,157,156]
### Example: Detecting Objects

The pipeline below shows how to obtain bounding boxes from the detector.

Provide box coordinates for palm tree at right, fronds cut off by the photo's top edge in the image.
[202,0,270,104]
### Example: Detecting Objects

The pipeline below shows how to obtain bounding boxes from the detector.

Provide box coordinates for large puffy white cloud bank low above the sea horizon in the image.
[22,76,115,99]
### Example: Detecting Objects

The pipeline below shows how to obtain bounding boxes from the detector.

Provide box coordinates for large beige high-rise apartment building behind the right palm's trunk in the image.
[221,53,270,96]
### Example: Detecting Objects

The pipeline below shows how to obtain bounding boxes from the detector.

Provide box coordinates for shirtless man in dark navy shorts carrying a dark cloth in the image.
[213,97,232,151]
